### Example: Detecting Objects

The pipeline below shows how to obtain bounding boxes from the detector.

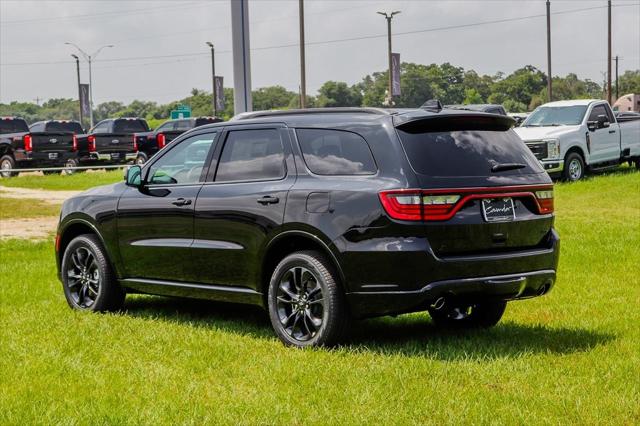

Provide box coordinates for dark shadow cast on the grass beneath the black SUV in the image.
[125,296,616,361]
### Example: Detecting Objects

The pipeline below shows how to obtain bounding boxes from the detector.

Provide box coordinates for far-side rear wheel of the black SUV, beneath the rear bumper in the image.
[429,301,507,328]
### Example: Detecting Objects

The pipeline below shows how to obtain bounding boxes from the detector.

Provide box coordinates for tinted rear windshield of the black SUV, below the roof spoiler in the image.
[398,129,543,177]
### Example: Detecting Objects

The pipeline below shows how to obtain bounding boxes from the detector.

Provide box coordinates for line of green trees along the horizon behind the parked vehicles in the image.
[0,62,640,127]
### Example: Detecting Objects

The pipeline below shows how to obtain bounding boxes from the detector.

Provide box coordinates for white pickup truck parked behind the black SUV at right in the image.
[514,99,640,181]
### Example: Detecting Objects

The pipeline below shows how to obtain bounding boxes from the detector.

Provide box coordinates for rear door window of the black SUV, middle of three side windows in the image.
[216,129,285,182]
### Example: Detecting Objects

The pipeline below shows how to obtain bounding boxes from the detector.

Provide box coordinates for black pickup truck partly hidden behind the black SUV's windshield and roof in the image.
[135,117,222,164]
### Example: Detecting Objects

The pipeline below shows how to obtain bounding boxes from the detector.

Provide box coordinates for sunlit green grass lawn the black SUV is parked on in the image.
[0,170,640,425]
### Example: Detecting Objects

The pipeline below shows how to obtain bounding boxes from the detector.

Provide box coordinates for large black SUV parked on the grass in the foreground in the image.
[56,107,559,346]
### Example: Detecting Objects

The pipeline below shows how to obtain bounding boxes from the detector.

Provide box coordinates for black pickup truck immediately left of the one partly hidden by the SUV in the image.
[78,118,149,164]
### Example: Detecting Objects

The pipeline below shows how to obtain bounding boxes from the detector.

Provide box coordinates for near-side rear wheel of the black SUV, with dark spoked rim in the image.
[267,251,349,348]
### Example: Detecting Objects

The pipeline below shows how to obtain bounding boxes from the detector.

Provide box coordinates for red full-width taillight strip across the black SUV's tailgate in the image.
[379,186,553,221]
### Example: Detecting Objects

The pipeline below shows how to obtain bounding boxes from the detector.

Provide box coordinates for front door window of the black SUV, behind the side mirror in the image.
[147,133,216,185]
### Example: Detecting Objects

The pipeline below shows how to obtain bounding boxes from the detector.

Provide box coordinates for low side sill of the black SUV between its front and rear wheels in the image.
[120,278,263,306]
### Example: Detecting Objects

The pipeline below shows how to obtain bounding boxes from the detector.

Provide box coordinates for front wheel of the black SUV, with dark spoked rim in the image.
[61,234,125,312]
